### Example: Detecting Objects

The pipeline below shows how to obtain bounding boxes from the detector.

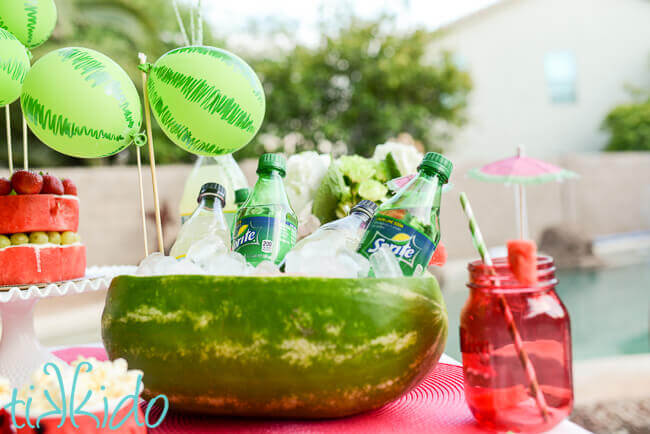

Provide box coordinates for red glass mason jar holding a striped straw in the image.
[460,256,573,432]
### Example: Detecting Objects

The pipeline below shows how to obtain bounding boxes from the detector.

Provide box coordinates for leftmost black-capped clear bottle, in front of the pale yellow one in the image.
[169,182,230,259]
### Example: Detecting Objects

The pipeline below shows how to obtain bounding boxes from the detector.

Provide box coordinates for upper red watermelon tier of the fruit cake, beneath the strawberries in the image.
[0,194,79,234]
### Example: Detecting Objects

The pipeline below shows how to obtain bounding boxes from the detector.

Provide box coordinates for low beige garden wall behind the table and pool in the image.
[0,153,650,265]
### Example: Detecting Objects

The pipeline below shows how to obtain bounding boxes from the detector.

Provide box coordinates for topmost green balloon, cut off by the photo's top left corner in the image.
[0,0,56,49]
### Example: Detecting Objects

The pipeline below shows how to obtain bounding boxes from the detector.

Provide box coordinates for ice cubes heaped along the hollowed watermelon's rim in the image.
[135,233,403,278]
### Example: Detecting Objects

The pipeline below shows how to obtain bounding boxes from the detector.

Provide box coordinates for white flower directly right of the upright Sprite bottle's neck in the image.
[284,151,332,214]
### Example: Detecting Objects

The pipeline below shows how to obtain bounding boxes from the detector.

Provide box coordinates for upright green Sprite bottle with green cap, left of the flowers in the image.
[232,154,298,266]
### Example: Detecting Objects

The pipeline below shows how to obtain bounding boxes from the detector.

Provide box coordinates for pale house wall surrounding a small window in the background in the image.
[435,0,650,160]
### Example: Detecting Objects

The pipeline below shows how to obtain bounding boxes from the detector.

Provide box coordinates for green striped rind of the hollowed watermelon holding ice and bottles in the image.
[102,276,447,418]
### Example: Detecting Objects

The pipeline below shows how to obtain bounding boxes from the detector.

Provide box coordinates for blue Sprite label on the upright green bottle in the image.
[232,216,298,265]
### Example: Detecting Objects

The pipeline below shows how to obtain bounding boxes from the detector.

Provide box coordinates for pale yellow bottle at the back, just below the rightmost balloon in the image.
[179,154,248,227]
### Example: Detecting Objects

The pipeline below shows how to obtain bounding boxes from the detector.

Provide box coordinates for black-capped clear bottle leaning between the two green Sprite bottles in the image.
[293,200,377,252]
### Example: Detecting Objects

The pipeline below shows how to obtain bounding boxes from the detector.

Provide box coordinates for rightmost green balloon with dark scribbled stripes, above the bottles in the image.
[147,46,266,156]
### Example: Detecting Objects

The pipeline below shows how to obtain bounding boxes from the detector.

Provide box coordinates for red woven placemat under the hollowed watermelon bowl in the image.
[55,348,485,434]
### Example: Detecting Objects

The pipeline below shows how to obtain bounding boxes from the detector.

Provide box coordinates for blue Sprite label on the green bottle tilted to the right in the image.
[359,214,436,276]
